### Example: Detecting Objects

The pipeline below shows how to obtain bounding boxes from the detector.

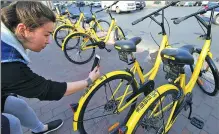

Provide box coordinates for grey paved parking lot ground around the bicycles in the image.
[23,7,219,134]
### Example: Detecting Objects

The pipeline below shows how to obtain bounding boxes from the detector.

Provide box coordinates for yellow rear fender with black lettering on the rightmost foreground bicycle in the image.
[126,84,178,134]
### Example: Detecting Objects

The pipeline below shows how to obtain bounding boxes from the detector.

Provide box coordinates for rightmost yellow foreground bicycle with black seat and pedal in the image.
[120,4,219,134]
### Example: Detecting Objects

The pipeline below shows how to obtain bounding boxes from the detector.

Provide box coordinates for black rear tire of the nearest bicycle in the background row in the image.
[63,33,95,65]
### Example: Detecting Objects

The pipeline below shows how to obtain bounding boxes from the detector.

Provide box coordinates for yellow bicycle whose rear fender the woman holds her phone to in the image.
[71,2,182,134]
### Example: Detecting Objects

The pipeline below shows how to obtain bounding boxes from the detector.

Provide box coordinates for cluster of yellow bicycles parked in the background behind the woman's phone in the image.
[53,2,125,64]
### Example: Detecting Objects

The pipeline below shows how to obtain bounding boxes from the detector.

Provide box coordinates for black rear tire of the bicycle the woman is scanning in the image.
[78,74,137,134]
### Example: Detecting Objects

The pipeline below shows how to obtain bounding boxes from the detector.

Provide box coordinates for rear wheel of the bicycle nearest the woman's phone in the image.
[78,74,137,134]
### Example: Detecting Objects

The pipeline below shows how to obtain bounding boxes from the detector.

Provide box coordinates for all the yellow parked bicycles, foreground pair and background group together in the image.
[53,2,219,134]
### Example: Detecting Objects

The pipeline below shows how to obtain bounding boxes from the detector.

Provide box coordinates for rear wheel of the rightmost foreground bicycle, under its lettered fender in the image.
[133,89,178,134]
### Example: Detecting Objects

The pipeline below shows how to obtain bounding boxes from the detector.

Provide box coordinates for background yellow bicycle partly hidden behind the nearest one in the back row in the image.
[53,4,109,50]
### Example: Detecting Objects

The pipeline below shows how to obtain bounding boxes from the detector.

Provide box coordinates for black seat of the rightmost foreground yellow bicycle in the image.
[161,47,194,65]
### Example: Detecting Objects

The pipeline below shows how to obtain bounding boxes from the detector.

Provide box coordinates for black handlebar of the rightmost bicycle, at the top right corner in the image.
[173,4,219,24]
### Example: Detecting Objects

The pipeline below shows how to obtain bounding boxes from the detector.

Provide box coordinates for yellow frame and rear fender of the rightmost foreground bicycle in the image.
[126,40,212,134]
